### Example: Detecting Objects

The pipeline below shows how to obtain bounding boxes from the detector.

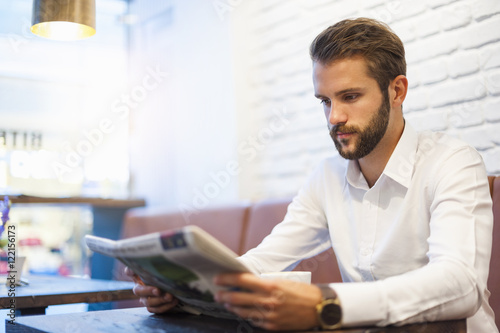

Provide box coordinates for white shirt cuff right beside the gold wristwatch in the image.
[329,282,387,327]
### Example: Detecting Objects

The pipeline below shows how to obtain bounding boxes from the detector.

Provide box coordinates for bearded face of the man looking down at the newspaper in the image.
[313,57,391,160]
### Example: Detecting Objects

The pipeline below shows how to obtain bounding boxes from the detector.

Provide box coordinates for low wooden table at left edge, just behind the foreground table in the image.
[0,276,137,315]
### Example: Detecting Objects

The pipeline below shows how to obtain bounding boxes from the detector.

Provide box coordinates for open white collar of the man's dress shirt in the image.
[346,122,418,190]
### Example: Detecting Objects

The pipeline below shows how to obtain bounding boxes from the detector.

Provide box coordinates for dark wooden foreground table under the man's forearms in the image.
[5,308,466,333]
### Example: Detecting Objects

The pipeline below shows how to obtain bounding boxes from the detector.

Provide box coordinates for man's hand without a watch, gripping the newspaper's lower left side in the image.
[125,267,178,314]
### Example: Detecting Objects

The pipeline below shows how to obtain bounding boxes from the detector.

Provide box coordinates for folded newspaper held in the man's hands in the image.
[85,226,251,318]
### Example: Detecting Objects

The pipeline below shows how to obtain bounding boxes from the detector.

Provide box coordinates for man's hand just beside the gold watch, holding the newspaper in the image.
[214,273,321,330]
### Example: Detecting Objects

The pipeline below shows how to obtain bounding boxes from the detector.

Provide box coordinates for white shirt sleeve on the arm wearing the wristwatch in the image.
[331,147,493,326]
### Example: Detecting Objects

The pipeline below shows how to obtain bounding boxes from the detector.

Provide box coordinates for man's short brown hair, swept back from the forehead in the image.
[310,18,406,92]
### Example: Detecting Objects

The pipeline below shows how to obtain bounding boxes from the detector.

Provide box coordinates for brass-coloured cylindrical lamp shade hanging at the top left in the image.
[31,0,95,40]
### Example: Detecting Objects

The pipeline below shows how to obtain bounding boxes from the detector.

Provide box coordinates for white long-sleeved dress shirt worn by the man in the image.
[240,123,498,333]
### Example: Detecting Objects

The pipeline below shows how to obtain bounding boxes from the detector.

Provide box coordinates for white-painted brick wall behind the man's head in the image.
[233,0,500,199]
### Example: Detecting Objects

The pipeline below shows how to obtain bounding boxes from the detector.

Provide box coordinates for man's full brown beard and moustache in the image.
[330,93,390,160]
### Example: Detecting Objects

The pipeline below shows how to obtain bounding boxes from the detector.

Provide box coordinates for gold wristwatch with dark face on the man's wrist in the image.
[316,284,342,330]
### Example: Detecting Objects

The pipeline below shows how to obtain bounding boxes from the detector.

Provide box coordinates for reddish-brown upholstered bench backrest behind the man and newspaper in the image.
[114,176,500,327]
